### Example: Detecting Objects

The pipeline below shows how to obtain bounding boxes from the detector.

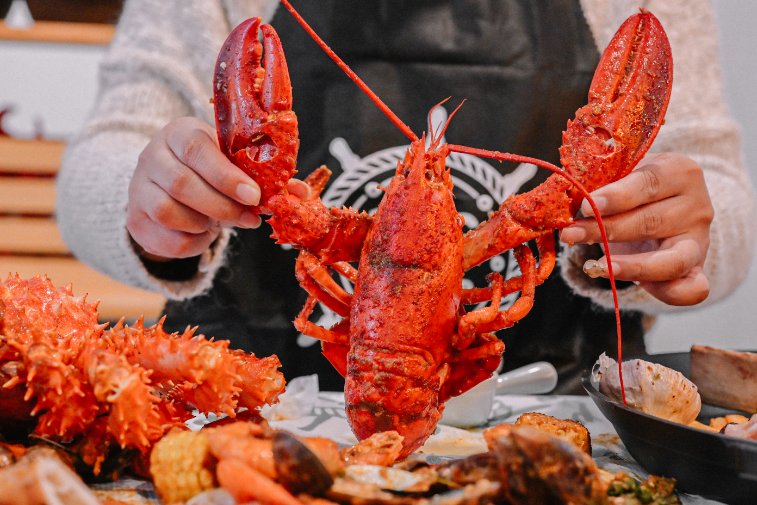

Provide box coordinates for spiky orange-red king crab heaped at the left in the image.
[0,275,284,474]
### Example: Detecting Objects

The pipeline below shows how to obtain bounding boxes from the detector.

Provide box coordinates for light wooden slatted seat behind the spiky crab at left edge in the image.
[0,137,165,322]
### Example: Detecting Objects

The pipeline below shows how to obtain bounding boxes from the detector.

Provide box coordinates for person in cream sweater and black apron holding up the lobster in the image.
[57,0,755,392]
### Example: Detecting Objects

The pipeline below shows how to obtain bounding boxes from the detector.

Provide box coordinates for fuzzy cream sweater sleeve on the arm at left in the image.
[56,0,256,298]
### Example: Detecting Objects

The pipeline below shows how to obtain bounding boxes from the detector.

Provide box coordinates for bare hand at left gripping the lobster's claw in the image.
[126,117,260,261]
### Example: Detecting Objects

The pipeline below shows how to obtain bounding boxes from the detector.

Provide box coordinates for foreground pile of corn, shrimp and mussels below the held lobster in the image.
[150,413,679,505]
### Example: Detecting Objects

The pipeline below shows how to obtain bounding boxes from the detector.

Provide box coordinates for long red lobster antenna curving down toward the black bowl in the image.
[447,144,628,405]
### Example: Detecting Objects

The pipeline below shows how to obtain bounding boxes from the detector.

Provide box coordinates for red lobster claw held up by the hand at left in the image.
[213,18,299,212]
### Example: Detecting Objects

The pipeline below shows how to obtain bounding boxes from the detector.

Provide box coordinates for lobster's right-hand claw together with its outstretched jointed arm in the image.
[458,11,672,269]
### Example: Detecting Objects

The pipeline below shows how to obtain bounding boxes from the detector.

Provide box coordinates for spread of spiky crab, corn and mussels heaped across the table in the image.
[0,275,678,505]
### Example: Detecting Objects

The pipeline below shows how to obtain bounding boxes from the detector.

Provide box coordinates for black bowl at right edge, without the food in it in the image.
[582,353,757,505]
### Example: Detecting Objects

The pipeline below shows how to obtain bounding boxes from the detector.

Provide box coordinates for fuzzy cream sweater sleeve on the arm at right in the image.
[559,0,757,314]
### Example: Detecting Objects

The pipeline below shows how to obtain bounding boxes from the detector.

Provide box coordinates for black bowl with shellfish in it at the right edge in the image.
[583,345,757,504]
